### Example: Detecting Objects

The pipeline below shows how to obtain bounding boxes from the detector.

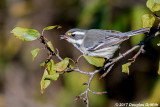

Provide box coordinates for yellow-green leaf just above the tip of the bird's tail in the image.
[142,14,155,28]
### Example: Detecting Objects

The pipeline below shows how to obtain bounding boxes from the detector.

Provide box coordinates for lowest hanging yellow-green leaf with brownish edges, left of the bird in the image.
[40,69,51,94]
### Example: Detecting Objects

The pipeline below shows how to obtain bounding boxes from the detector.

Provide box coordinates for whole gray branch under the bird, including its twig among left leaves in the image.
[39,26,160,107]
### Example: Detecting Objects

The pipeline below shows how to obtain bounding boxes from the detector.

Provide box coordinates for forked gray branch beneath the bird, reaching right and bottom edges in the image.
[73,29,160,107]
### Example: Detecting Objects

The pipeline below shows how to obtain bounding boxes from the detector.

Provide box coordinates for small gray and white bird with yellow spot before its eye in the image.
[60,27,149,59]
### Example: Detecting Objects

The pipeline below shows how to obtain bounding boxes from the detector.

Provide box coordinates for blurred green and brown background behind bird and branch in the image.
[0,0,160,107]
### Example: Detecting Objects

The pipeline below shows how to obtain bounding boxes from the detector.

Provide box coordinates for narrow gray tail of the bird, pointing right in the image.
[121,27,149,37]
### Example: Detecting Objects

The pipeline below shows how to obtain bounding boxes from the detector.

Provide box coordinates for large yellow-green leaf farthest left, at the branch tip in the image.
[11,27,40,41]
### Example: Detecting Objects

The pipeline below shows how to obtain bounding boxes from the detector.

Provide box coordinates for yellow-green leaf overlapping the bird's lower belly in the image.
[84,55,105,67]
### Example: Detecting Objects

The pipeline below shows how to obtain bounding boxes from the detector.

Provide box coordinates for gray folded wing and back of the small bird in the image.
[83,29,129,51]
